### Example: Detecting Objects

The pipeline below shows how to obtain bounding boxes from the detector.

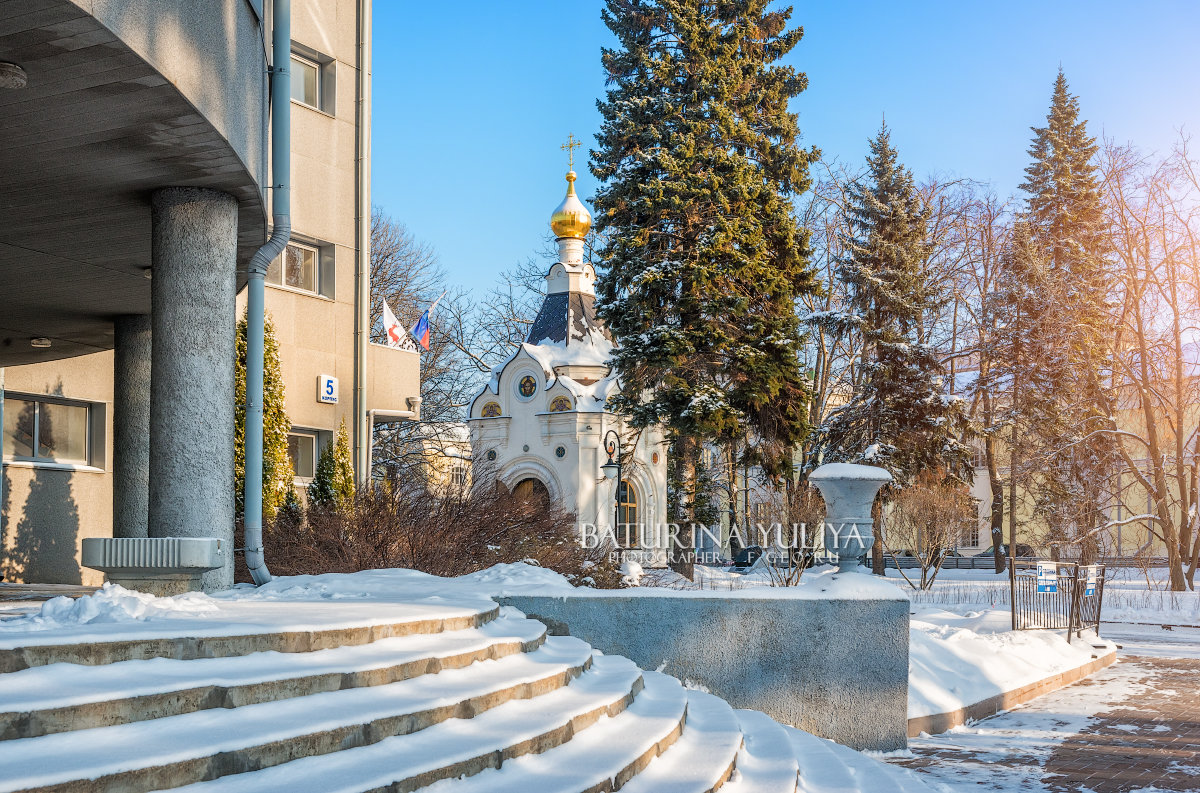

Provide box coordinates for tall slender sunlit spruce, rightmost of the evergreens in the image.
[1021,70,1114,555]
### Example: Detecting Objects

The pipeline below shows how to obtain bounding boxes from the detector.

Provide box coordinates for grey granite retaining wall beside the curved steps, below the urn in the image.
[499,590,910,751]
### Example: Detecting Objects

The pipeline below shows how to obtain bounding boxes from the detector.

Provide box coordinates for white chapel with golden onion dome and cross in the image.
[468,159,667,566]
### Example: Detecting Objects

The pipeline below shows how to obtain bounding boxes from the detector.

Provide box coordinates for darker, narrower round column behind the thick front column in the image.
[113,314,151,537]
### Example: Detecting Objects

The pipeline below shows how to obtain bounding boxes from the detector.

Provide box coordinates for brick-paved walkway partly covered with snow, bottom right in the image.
[892,629,1200,793]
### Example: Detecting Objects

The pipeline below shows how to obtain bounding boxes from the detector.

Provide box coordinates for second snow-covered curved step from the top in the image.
[0,617,546,740]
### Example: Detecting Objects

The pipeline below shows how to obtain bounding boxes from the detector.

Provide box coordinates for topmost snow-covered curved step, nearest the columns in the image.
[0,601,499,673]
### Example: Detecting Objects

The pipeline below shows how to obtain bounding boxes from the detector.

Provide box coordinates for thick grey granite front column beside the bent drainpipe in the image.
[149,187,238,590]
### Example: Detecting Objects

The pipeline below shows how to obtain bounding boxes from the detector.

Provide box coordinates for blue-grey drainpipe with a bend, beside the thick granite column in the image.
[244,0,292,587]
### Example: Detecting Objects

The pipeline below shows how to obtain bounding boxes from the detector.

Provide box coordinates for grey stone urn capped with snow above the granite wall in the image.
[809,463,892,572]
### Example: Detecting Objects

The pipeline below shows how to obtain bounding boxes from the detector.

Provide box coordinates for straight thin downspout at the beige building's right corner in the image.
[354,0,373,487]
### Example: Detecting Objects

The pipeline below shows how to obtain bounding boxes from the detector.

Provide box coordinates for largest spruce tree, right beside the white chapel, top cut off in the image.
[592,0,817,544]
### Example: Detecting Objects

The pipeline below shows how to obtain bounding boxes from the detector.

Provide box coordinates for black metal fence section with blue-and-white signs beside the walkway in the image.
[1012,559,1105,639]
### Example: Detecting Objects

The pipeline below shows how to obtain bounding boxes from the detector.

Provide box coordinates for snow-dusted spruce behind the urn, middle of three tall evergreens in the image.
[815,126,972,487]
